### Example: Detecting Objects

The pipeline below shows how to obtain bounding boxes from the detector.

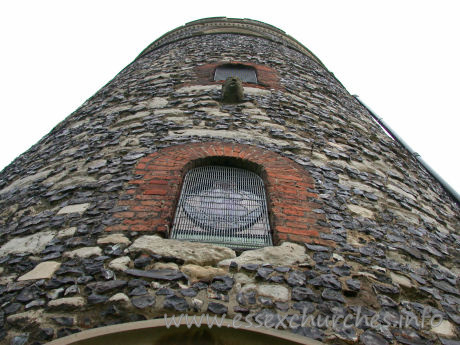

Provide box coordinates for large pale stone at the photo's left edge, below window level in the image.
[0,231,55,257]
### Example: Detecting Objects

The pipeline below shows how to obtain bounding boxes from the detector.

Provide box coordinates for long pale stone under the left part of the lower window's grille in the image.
[128,235,236,266]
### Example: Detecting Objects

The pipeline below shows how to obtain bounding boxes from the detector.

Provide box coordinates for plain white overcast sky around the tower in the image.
[0,0,460,192]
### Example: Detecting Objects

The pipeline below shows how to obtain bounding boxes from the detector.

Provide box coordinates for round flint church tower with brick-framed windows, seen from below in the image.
[0,17,460,345]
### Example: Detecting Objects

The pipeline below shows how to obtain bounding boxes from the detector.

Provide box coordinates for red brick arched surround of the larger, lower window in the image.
[107,142,334,246]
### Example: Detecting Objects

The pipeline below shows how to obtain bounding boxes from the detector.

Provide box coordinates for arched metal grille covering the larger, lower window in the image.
[171,165,272,249]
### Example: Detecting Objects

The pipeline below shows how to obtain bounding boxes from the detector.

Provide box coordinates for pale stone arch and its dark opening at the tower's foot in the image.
[44,317,323,345]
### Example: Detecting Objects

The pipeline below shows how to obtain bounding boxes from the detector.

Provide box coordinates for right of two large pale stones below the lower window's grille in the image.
[219,242,314,266]
